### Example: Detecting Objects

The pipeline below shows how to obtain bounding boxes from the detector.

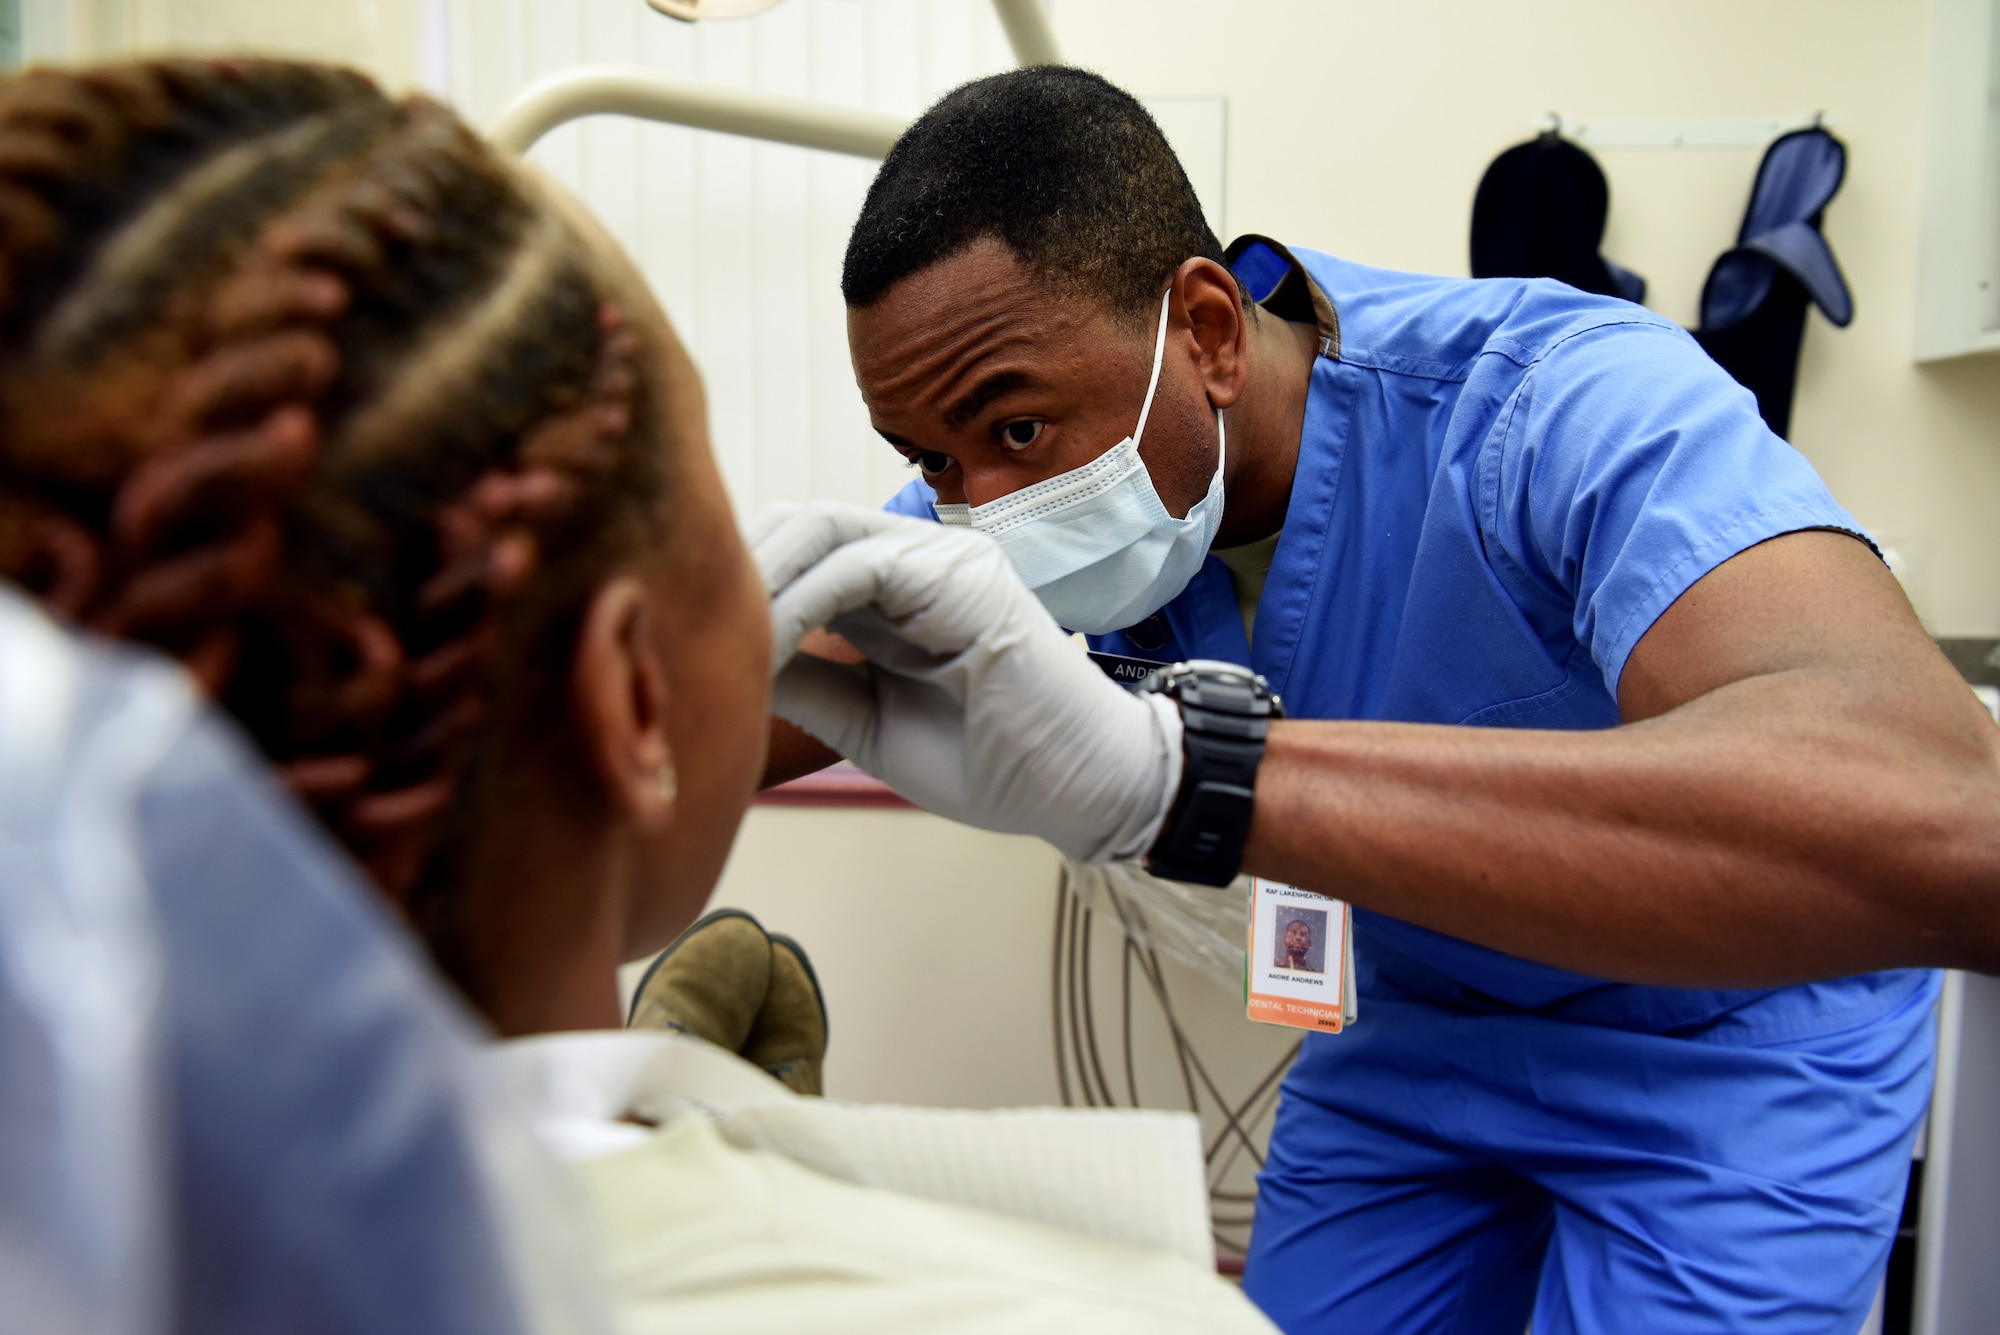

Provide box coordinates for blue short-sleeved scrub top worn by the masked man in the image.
[888,238,1930,1041]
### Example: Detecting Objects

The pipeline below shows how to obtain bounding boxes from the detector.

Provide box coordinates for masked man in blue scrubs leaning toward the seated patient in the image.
[752,70,2000,1335]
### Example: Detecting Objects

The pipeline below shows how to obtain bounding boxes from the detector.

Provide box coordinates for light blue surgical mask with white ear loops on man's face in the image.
[936,292,1226,636]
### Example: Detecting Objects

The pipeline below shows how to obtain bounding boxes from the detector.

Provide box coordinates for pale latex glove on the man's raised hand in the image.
[750,502,1180,861]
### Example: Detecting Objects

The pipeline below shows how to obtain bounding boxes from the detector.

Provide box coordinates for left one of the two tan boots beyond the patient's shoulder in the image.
[626,909,772,1051]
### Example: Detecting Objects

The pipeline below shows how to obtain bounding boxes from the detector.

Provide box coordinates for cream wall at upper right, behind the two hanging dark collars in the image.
[1052,0,2000,636]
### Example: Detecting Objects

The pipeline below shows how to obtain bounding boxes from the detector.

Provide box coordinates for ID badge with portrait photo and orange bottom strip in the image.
[1244,875,1356,1033]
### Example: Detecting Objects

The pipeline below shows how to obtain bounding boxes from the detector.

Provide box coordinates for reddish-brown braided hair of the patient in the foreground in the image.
[0,62,664,983]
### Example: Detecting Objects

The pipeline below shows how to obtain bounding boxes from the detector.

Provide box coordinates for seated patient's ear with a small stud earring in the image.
[570,576,678,825]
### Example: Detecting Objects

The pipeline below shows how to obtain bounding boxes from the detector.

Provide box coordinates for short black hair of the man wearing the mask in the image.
[840,66,1222,316]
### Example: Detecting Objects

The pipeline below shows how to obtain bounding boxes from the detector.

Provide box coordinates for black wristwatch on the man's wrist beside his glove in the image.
[1138,660,1284,885]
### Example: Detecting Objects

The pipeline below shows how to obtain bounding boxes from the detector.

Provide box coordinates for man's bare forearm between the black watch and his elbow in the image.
[1246,673,2000,985]
